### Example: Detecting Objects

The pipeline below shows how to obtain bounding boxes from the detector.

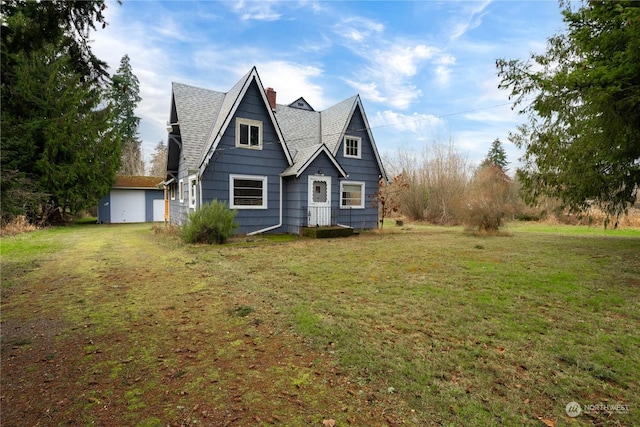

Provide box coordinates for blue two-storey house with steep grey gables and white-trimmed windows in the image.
[165,67,386,234]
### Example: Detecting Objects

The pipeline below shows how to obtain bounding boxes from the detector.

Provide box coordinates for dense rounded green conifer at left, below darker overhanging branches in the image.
[2,46,120,222]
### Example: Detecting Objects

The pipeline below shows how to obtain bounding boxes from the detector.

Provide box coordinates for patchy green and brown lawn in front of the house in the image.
[2,224,640,426]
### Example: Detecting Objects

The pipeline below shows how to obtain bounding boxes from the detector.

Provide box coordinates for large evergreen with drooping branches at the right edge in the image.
[496,0,640,221]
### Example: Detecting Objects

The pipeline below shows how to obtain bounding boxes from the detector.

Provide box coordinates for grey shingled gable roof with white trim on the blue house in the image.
[173,67,386,178]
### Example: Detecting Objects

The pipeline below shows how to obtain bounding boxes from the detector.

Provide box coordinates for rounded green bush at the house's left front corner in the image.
[180,200,238,244]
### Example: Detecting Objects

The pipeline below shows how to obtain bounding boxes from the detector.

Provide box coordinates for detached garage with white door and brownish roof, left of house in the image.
[98,176,165,224]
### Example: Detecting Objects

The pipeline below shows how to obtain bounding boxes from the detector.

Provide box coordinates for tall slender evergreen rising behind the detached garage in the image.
[109,55,144,175]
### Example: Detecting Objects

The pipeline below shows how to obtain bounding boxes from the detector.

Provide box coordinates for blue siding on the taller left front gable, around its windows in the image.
[202,81,288,233]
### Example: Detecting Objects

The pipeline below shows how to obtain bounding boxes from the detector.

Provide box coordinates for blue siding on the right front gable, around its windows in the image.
[336,108,382,229]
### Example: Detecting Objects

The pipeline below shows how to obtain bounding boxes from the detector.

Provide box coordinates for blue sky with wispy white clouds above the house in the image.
[91,0,564,172]
